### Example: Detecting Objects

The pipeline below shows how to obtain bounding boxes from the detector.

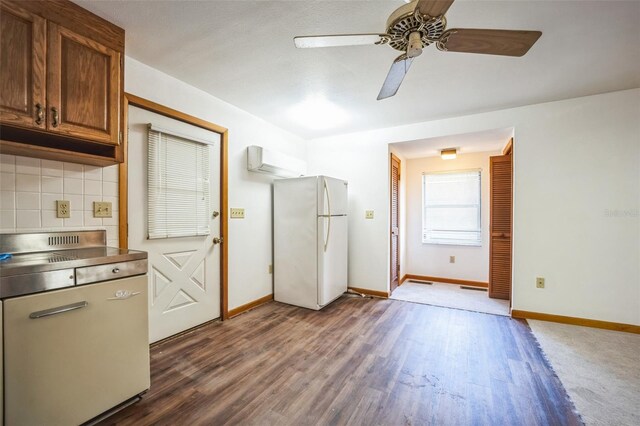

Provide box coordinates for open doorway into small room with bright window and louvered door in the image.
[390,128,513,316]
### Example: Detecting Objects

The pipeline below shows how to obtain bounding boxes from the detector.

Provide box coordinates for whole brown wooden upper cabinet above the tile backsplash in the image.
[0,0,124,165]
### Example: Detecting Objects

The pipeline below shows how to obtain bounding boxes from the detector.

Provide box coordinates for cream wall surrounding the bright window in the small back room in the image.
[406,151,506,282]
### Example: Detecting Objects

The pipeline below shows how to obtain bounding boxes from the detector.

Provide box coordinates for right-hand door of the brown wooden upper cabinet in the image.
[47,22,122,144]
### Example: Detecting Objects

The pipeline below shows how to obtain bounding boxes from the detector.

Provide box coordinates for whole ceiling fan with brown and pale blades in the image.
[293,0,542,100]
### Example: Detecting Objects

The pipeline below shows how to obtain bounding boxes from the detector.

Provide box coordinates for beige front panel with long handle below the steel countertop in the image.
[3,275,149,426]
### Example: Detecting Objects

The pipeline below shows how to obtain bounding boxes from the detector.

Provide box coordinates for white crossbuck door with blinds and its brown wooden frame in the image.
[121,95,227,342]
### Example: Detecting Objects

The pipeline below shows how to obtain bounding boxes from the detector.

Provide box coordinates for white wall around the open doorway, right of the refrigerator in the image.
[308,89,640,324]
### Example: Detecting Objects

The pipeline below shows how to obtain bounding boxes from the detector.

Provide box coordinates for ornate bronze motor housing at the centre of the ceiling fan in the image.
[387,2,447,52]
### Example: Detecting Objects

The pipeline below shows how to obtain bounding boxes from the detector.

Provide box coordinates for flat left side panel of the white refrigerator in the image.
[273,176,321,309]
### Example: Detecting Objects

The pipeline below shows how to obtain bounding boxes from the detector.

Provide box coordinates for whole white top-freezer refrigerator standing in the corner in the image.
[273,176,348,310]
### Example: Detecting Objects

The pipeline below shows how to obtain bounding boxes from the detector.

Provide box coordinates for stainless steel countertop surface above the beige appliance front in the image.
[0,246,147,277]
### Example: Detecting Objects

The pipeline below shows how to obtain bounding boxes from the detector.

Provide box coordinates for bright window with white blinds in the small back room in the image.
[422,170,482,246]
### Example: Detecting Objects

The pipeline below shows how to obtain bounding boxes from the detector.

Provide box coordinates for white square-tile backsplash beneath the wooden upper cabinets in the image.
[0,154,119,246]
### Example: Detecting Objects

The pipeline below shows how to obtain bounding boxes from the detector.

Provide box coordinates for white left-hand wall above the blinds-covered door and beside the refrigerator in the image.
[125,57,306,309]
